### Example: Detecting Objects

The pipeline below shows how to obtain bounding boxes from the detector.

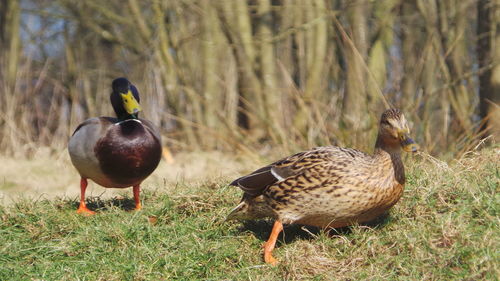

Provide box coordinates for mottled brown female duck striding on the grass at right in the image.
[228,109,418,264]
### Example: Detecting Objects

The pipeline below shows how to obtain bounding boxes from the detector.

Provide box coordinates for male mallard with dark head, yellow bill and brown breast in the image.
[68,78,162,215]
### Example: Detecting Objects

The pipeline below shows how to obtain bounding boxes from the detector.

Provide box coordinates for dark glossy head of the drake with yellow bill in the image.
[110,77,142,120]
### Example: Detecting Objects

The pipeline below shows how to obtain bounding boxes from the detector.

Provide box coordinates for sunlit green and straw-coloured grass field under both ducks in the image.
[0,147,500,280]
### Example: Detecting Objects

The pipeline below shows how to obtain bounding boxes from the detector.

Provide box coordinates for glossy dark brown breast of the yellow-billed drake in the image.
[94,120,161,187]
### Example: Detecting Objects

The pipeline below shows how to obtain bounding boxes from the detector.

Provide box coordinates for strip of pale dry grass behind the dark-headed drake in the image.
[0,148,248,204]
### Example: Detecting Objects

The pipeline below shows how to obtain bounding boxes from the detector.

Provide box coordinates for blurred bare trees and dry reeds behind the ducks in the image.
[0,0,500,158]
